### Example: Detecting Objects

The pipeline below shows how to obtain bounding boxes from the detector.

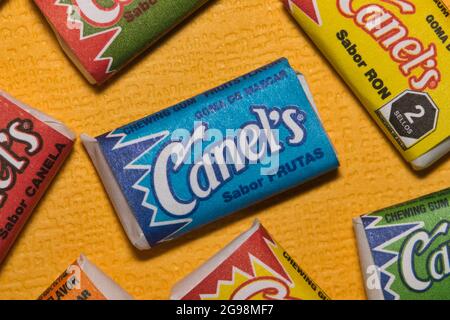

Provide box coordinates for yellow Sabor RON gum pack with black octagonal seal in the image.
[283,0,450,170]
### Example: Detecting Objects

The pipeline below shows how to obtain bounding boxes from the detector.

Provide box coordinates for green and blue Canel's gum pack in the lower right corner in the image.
[353,189,450,300]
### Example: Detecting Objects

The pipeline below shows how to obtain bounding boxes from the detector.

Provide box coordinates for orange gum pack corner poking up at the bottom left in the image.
[38,255,134,300]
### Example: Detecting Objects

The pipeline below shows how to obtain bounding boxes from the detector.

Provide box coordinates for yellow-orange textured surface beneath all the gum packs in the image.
[0,0,450,299]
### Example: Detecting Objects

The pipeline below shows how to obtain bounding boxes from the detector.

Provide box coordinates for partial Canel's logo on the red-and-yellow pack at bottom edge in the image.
[230,277,299,300]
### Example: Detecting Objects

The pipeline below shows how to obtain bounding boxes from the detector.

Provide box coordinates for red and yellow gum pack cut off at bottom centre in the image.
[171,221,330,300]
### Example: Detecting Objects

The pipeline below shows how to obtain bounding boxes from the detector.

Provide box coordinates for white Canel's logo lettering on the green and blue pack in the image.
[399,221,450,292]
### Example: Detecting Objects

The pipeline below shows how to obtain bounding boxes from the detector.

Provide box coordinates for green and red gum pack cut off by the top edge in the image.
[34,0,207,84]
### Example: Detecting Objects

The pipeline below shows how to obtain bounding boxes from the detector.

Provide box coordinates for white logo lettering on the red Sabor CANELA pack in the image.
[0,119,42,208]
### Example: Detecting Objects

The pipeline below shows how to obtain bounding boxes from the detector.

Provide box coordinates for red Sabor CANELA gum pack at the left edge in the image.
[0,91,75,264]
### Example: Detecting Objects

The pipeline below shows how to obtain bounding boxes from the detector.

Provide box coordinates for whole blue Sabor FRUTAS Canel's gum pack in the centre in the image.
[82,59,339,250]
